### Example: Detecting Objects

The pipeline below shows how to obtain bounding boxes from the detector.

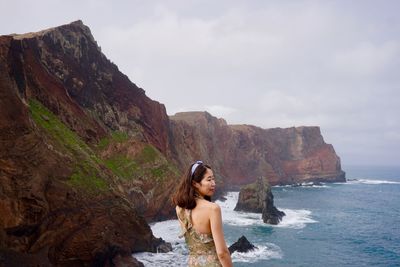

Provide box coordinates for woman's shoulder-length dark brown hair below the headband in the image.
[172,163,211,210]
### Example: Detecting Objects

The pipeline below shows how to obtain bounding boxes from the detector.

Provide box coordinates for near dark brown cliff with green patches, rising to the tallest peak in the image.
[0,21,176,266]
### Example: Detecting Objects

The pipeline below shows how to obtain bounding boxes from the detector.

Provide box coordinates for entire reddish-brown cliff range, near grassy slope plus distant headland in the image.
[0,21,344,265]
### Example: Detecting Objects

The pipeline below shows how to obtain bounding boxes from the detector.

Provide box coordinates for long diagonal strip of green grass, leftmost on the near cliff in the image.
[29,99,108,194]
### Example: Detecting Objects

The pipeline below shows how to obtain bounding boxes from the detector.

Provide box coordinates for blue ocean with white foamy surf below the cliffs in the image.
[133,166,400,267]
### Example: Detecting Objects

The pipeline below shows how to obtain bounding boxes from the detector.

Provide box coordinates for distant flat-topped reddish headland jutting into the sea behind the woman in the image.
[170,112,345,189]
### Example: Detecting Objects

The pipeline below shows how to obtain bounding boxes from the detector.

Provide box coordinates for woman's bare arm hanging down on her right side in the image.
[210,204,233,267]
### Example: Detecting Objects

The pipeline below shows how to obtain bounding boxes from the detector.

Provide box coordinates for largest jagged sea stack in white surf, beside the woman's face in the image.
[235,177,285,224]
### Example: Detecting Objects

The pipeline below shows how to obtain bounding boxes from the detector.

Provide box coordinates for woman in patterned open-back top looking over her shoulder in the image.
[173,161,233,267]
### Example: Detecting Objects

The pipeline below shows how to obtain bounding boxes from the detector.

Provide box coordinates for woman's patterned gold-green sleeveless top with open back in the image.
[178,208,222,267]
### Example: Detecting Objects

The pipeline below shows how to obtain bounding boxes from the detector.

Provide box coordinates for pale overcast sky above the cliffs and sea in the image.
[0,0,400,166]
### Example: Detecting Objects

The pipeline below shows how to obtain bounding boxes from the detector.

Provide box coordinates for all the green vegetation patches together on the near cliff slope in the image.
[29,100,178,191]
